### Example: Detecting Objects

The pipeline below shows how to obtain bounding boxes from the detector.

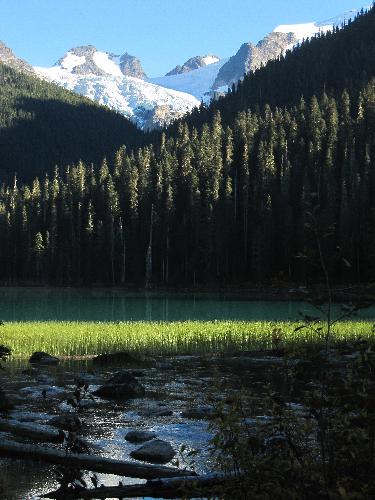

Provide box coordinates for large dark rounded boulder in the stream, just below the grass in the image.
[94,372,145,399]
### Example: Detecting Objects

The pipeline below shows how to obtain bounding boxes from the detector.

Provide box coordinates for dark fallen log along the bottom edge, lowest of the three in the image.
[42,473,235,500]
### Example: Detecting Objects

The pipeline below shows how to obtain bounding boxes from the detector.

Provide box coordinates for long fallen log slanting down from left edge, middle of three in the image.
[0,440,194,479]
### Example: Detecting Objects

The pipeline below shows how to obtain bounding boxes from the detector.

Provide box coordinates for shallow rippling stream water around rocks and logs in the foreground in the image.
[0,356,276,500]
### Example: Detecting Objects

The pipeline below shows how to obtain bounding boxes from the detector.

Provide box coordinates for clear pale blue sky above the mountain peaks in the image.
[0,0,371,76]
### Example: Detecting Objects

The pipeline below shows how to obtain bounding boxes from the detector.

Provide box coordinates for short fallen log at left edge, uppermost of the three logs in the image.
[0,418,65,443]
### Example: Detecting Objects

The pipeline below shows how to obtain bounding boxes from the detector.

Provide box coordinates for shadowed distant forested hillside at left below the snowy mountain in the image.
[0,64,143,181]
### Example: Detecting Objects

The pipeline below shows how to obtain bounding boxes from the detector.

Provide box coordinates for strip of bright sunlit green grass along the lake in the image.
[0,321,375,357]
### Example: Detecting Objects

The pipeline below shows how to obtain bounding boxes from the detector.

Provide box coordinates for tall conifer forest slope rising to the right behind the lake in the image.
[0,3,375,285]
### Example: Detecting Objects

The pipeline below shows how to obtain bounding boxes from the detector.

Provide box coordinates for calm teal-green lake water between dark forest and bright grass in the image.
[0,288,375,321]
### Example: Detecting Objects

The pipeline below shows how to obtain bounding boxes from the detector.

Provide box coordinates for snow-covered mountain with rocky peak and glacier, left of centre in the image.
[35,45,199,129]
